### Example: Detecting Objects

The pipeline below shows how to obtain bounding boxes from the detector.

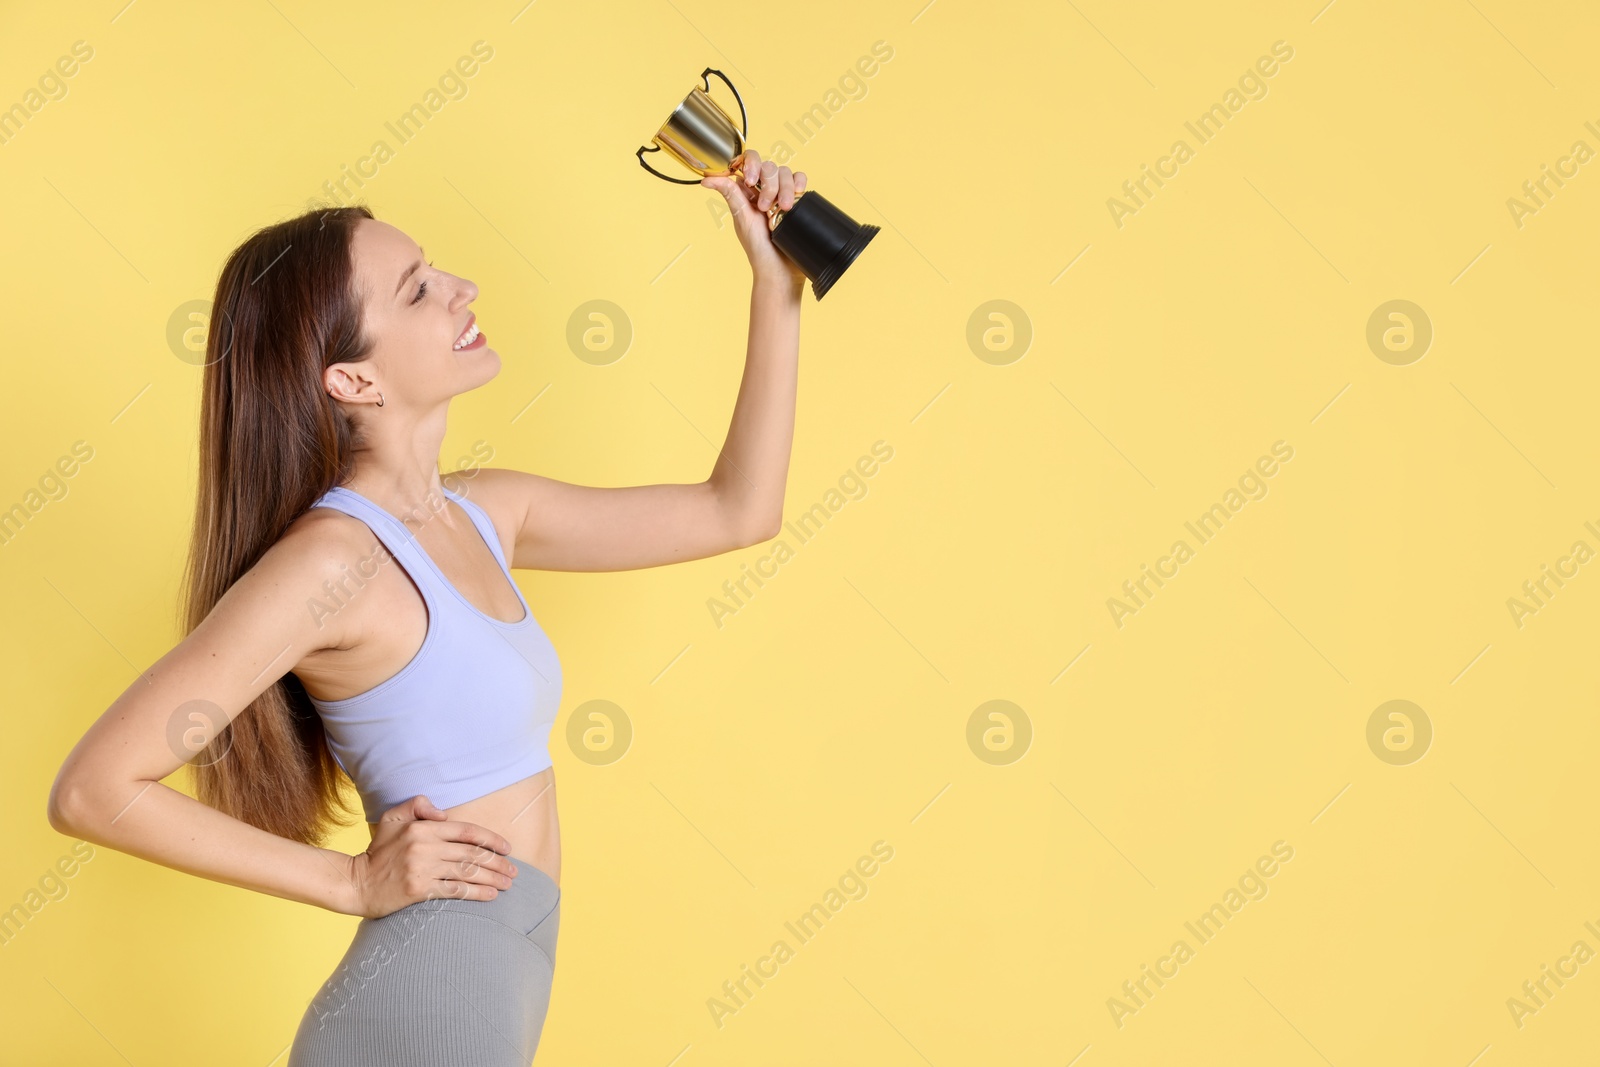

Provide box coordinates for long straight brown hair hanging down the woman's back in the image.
[179,205,373,845]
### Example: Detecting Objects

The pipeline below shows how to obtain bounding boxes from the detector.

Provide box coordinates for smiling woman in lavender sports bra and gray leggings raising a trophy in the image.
[50,152,805,1067]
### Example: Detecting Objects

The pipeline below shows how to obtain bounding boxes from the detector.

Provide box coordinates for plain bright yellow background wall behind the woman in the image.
[0,0,1600,1067]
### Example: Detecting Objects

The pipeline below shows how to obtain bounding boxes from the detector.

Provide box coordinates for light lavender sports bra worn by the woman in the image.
[299,486,562,822]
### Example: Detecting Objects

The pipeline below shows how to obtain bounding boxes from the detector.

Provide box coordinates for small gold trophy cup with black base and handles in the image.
[634,67,878,299]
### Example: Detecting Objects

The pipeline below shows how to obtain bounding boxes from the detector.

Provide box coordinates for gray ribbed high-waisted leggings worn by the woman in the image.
[288,857,562,1067]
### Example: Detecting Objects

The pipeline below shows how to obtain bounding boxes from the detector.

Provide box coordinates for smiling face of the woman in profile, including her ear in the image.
[323,219,499,410]
